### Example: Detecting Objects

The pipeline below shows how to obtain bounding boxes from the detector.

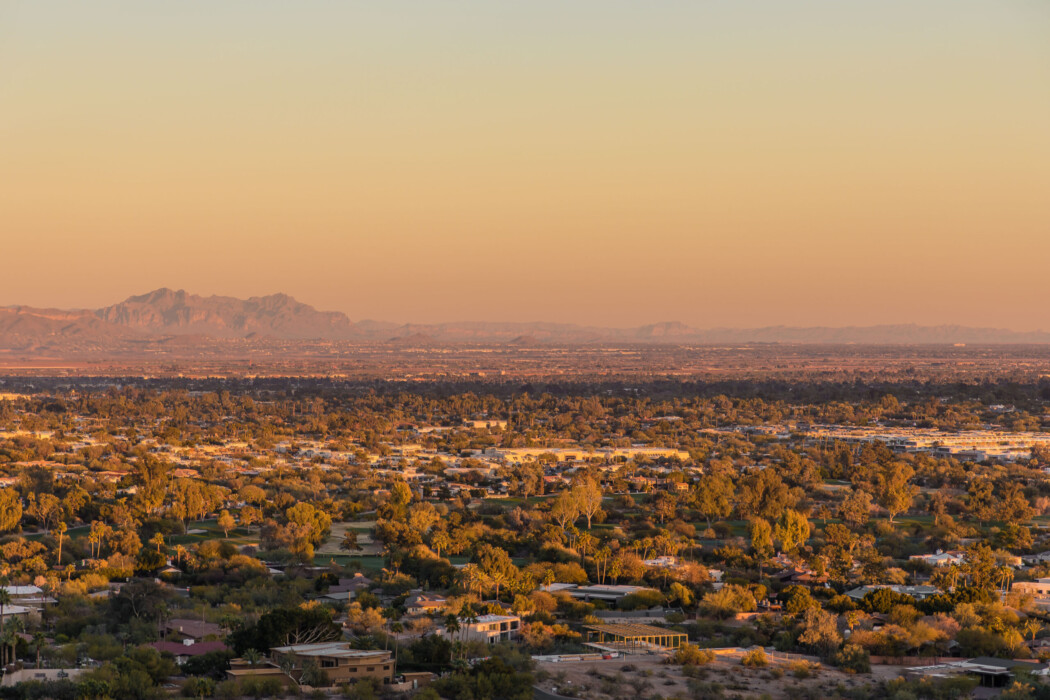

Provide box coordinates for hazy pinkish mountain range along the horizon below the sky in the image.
[0,289,1050,352]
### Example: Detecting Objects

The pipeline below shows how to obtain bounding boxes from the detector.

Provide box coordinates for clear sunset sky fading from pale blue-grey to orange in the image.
[0,0,1050,330]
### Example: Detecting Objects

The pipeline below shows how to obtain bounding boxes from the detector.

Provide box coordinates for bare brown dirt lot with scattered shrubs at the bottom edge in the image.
[537,654,900,700]
